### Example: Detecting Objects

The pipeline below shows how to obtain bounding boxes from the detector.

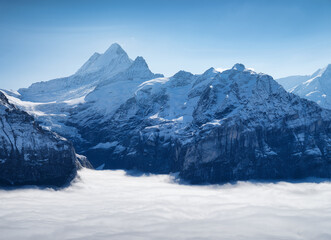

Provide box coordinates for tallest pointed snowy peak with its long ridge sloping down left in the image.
[18,43,132,103]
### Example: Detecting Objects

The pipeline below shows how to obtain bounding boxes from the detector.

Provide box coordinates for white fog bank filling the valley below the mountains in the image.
[0,169,331,240]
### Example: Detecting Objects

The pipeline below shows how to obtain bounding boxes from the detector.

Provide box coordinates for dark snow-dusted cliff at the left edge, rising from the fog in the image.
[0,92,80,186]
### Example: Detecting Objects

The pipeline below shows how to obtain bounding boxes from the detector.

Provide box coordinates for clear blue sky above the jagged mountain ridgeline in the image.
[0,0,331,90]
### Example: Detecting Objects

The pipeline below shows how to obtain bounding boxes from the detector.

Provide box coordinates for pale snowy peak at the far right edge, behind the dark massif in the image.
[277,64,331,109]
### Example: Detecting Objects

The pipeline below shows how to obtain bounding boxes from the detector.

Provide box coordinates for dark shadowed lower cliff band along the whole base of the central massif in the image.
[83,109,331,183]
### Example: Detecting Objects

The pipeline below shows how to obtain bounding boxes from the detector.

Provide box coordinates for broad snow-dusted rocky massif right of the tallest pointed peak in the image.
[74,65,331,183]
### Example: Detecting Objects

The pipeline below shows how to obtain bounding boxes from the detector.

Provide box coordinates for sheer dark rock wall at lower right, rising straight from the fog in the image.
[181,121,331,183]
